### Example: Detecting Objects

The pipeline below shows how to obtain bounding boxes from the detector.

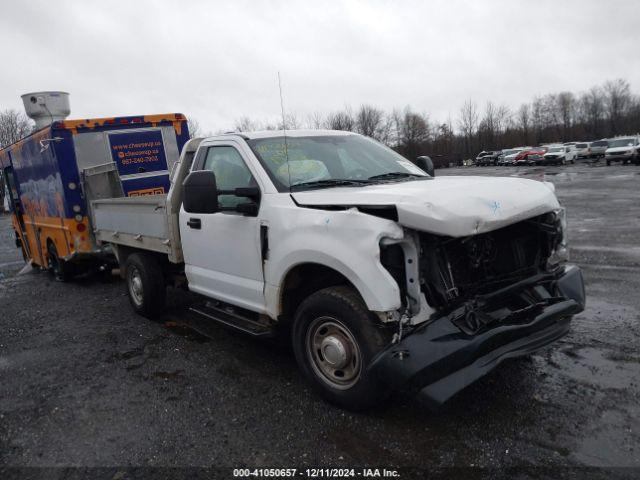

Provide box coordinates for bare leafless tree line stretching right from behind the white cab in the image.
[229,79,640,162]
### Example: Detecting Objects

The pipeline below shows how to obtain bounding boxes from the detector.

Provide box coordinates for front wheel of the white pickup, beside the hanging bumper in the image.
[292,286,391,410]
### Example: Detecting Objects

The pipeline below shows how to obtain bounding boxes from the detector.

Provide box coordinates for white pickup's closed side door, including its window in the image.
[180,141,266,312]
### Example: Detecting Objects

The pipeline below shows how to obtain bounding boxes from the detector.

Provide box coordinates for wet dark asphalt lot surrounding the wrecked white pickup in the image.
[0,164,640,475]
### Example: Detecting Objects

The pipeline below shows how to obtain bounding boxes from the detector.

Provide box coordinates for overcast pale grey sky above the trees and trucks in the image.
[0,0,640,131]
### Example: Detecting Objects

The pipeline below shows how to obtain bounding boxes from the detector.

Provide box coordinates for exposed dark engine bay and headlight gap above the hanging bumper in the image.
[381,212,563,334]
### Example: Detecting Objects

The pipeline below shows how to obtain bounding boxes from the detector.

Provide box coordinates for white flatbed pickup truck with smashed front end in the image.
[92,131,585,409]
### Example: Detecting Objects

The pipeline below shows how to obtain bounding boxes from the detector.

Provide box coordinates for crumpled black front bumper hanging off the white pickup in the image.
[369,265,585,407]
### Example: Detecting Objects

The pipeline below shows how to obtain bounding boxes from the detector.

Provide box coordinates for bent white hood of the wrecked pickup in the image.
[291,176,560,237]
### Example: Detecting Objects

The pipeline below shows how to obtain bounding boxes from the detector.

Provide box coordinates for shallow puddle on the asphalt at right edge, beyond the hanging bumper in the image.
[551,347,640,389]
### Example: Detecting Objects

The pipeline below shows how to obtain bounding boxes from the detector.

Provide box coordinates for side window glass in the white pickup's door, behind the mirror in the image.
[202,146,257,207]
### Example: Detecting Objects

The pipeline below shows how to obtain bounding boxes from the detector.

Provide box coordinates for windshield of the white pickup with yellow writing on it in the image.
[247,135,429,192]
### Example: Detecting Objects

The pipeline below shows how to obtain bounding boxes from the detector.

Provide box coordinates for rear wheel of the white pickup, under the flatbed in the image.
[125,253,167,318]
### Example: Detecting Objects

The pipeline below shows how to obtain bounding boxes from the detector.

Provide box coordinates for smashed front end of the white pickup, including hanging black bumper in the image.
[370,211,585,406]
